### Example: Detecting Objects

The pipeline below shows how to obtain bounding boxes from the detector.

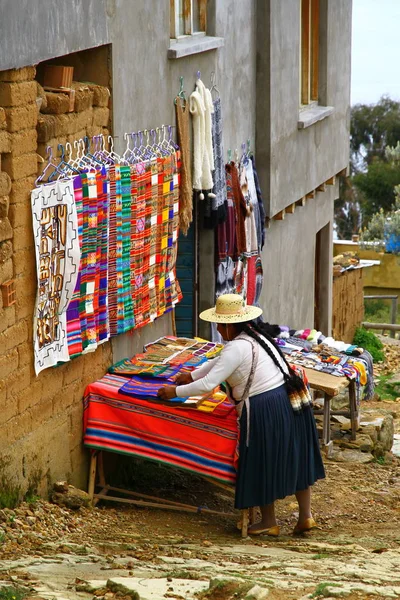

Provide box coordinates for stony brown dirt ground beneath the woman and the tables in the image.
[0,340,400,600]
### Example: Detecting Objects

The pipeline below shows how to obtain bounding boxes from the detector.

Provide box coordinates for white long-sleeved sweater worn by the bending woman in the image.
[176,334,286,400]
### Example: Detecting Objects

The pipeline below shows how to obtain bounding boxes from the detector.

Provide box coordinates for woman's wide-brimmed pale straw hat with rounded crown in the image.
[199,294,262,323]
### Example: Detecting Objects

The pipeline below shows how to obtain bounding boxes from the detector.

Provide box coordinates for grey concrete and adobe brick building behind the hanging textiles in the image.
[0,0,351,492]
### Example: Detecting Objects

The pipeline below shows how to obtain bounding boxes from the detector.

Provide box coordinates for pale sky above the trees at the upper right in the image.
[351,0,400,105]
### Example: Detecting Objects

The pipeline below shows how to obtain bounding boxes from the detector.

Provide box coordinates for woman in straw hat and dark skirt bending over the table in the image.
[159,294,325,536]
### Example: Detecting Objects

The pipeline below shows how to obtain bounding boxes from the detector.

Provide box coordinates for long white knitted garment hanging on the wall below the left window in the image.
[189,79,214,190]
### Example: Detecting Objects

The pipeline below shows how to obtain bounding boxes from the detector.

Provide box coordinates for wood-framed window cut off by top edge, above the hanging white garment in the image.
[170,0,207,40]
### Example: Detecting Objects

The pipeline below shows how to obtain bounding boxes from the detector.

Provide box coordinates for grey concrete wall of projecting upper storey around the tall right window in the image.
[257,0,352,216]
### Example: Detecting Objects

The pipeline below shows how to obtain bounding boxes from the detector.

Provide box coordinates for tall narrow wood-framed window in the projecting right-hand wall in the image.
[300,0,320,105]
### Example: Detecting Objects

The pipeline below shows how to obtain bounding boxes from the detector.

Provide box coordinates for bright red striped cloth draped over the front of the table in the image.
[83,374,238,484]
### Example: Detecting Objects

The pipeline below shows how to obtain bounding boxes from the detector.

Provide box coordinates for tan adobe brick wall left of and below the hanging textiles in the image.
[0,67,112,494]
